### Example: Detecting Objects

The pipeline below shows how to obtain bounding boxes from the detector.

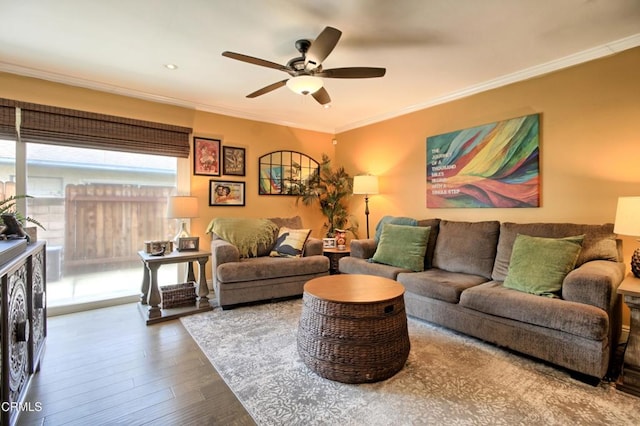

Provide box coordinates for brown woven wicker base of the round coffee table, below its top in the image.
[298,293,410,383]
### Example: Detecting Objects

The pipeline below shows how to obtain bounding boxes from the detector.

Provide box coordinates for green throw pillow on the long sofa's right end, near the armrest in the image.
[504,234,584,297]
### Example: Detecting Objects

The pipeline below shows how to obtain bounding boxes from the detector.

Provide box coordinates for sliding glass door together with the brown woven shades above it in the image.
[0,98,191,312]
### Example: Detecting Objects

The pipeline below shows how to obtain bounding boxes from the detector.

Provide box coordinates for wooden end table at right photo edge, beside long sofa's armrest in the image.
[616,274,640,396]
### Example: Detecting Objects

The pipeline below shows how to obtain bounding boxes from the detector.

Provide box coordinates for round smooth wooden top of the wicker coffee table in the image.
[304,274,404,303]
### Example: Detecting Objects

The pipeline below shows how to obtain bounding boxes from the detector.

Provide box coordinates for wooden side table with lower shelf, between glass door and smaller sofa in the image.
[138,250,213,325]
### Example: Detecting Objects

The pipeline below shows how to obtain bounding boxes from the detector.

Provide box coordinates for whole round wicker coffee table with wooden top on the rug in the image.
[298,274,410,383]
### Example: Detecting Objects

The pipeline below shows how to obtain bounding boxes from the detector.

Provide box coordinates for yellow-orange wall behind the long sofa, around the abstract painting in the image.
[336,48,640,258]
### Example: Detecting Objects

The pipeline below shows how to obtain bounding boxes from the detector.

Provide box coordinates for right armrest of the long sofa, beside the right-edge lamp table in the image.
[562,260,625,314]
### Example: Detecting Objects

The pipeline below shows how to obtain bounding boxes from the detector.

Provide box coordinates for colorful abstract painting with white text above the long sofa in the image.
[427,114,540,208]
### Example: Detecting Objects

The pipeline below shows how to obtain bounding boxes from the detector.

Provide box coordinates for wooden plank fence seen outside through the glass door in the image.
[64,184,174,271]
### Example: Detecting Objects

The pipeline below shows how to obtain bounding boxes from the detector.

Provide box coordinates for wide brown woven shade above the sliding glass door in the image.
[0,100,192,158]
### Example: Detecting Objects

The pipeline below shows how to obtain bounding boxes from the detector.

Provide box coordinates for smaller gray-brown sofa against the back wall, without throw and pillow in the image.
[211,216,329,309]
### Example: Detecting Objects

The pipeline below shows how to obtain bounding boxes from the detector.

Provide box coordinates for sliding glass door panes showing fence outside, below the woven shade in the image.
[26,143,177,307]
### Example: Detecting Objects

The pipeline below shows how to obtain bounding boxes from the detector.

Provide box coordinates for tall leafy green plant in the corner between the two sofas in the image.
[297,154,358,238]
